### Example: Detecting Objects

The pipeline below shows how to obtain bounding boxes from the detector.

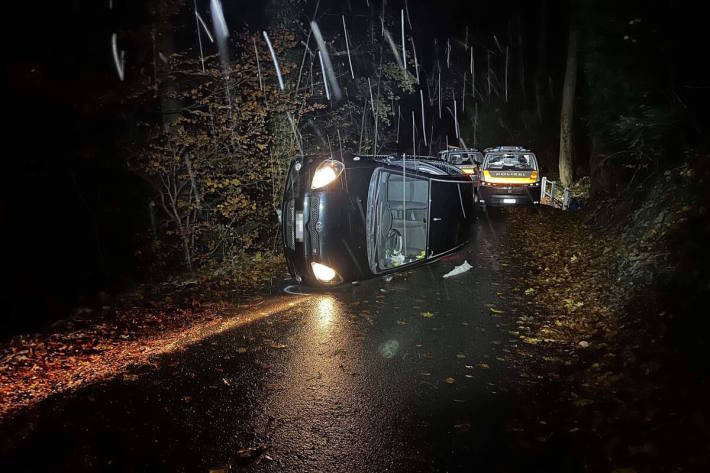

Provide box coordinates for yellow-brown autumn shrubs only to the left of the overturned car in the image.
[131,30,322,268]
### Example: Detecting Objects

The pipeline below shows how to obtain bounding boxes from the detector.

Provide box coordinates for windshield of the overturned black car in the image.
[367,170,429,272]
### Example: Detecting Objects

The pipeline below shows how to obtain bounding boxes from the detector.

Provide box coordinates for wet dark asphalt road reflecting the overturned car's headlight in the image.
[3,212,559,472]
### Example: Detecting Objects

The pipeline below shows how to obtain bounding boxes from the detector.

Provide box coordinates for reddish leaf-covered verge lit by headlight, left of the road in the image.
[0,253,285,418]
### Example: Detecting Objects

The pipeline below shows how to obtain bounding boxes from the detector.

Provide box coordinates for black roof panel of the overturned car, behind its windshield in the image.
[428,179,471,258]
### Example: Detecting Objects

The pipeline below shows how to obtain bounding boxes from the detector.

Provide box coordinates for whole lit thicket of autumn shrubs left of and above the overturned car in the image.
[130,0,422,269]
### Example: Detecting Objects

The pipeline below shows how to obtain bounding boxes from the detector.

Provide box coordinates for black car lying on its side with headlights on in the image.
[282,153,474,286]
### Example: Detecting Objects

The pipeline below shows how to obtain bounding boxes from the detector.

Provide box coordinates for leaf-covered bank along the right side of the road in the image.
[501,167,710,471]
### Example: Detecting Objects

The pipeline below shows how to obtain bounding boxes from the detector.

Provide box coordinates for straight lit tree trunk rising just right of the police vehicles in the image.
[559,12,579,186]
